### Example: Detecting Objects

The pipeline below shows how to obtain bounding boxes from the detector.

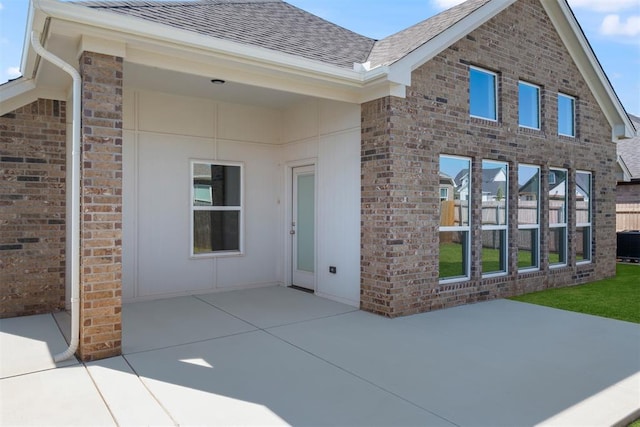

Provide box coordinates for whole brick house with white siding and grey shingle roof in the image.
[0,0,635,360]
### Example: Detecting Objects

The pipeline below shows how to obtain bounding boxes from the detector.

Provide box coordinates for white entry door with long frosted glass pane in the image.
[289,166,316,290]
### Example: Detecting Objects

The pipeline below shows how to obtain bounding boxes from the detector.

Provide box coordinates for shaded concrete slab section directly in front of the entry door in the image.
[198,286,358,328]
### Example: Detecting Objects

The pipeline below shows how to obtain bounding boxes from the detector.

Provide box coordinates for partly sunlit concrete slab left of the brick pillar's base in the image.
[0,314,78,378]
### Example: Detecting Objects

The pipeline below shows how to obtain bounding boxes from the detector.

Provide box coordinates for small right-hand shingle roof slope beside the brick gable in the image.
[367,0,490,68]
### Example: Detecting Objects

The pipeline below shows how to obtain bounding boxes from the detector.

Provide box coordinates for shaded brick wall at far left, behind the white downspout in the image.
[0,99,66,317]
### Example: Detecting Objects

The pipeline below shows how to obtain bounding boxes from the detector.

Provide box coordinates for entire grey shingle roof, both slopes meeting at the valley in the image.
[76,0,490,69]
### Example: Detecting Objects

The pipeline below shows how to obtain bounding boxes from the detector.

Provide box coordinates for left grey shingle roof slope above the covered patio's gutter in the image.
[76,0,375,69]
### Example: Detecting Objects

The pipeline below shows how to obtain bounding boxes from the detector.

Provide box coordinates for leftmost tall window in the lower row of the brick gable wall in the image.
[439,155,471,281]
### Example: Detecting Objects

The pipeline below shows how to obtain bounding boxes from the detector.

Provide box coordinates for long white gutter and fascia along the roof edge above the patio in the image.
[33,0,376,87]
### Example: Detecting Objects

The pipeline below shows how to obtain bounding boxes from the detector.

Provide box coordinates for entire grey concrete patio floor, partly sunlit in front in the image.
[0,287,640,426]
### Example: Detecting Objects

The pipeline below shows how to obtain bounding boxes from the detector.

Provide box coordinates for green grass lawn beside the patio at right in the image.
[511,264,640,323]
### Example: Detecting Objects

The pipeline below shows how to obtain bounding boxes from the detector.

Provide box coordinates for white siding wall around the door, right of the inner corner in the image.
[283,100,360,306]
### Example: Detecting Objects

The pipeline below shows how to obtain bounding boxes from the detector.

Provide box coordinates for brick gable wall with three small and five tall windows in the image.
[361,0,616,317]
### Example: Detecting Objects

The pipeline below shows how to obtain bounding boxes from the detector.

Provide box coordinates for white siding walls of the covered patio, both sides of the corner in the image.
[123,89,360,306]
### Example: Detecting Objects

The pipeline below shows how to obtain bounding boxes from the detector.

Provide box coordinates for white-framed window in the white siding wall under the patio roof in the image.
[191,161,242,256]
